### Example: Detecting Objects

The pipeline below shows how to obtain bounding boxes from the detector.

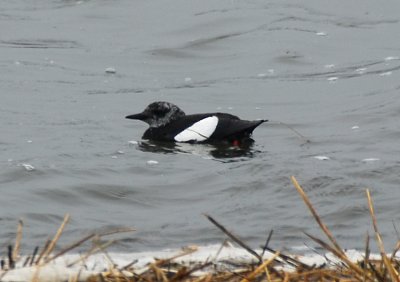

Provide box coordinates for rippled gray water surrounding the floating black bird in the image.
[0,0,400,254]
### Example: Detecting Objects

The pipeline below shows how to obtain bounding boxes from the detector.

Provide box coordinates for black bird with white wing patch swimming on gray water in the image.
[126,102,267,145]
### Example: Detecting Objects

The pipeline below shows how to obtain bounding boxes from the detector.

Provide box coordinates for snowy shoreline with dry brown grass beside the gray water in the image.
[0,177,400,282]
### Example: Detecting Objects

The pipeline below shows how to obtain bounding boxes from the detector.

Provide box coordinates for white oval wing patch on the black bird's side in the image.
[174,116,218,142]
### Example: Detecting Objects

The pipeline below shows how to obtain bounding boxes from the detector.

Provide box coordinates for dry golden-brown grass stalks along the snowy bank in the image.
[0,177,400,282]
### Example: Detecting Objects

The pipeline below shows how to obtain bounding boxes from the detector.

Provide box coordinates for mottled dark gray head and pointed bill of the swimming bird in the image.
[126,102,185,127]
